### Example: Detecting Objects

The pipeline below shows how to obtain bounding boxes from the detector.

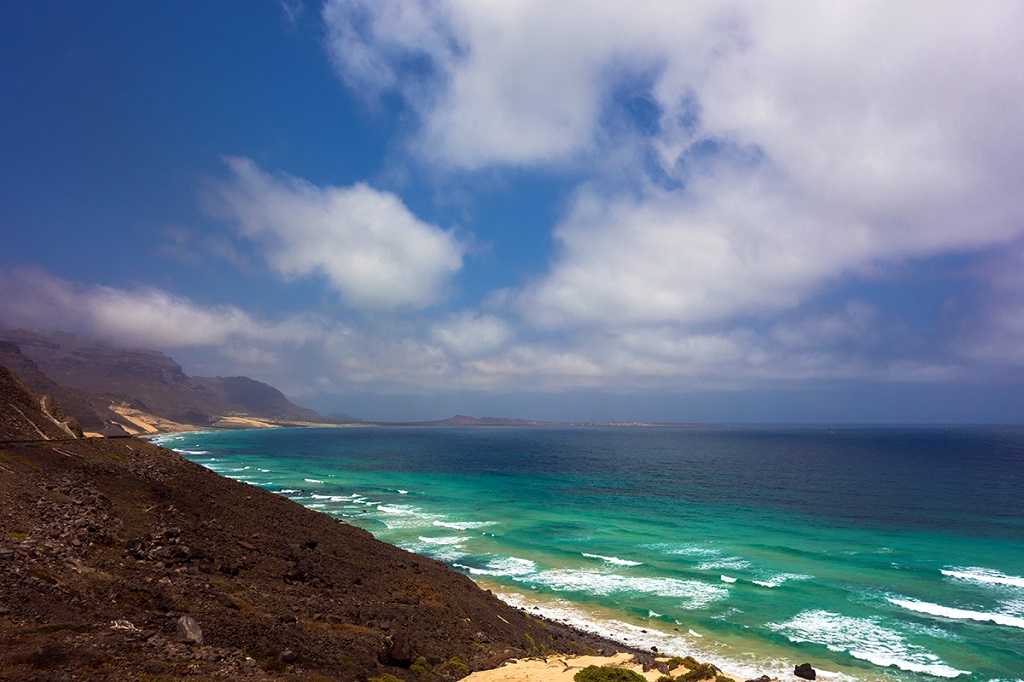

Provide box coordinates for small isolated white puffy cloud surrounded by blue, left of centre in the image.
[214,158,465,309]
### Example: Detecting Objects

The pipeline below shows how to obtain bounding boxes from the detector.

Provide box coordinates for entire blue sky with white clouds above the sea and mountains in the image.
[0,0,1024,423]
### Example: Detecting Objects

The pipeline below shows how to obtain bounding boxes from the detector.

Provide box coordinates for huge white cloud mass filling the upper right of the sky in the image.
[324,0,1024,328]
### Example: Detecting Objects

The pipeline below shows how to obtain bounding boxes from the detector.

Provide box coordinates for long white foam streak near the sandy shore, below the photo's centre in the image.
[527,568,729,608]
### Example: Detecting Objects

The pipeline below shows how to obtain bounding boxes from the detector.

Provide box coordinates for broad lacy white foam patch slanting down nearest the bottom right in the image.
[767,610,971,678]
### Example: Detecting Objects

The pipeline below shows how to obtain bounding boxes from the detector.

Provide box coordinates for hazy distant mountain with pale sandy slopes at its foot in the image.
[0,330,328,435]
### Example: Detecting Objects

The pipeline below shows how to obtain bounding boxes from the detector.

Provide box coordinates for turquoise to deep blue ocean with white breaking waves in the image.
[156,426,1024,682]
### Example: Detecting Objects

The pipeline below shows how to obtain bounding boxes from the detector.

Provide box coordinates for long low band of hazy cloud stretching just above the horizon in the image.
[0,269,995,397]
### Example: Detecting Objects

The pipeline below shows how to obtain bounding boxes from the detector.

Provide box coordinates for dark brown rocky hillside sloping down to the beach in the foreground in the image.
[0,370,626,682]
